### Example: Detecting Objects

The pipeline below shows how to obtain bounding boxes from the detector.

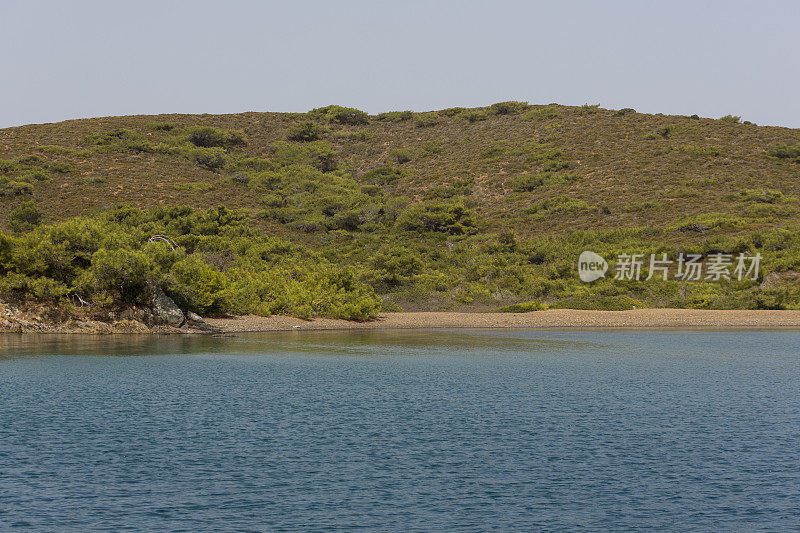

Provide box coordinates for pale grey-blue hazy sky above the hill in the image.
[0,0,800,127]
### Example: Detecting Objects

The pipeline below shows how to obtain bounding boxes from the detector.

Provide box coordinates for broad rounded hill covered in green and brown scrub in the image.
[0,102,800,319]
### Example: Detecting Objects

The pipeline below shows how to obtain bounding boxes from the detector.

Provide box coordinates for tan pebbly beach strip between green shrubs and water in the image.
[206,309,800,333]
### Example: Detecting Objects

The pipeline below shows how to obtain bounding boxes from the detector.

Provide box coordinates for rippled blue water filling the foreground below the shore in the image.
[0,330,800,531]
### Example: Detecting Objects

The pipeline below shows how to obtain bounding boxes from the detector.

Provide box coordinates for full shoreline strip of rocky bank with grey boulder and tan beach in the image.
[0,290,800,335]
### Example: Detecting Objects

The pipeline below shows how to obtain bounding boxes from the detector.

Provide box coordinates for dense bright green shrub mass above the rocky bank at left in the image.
[0,207,380,320]
